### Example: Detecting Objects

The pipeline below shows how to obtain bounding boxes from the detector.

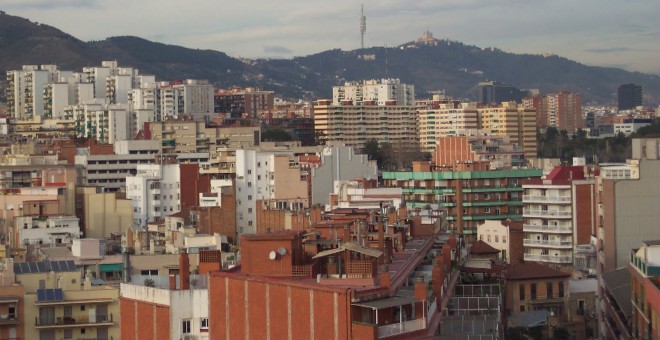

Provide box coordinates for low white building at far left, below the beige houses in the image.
[15,216,81,246]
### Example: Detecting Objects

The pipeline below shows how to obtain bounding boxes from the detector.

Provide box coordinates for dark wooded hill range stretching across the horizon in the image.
[0,13,660,104]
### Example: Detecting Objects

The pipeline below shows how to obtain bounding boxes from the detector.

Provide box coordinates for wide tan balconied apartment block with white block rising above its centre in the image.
[314,79,419,148]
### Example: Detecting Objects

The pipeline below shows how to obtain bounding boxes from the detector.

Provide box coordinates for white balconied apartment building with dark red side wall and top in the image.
[522,166,596,274]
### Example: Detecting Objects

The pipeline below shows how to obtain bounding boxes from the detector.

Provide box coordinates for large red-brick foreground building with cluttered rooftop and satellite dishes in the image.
[209,223,459,339]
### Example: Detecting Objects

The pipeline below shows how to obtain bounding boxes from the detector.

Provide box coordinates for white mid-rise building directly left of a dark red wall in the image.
[126,164,181,226]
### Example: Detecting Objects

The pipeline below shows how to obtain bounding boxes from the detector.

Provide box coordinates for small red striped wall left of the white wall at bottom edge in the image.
[119,298,170,339]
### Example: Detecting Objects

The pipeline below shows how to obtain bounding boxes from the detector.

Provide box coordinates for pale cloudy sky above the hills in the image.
[5,0,660,74]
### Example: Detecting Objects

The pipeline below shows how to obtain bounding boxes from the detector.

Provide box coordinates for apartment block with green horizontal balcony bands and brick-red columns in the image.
[382,161,542,241]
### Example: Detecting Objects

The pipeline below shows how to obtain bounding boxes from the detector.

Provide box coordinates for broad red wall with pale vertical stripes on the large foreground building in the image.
[209,272,356,339]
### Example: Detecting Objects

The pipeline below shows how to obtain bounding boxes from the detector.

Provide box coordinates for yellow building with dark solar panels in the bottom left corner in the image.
[14,261,119,339]
